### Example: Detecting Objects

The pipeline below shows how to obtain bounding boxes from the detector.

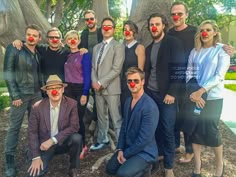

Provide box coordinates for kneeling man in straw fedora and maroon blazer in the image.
[28,75,82,177]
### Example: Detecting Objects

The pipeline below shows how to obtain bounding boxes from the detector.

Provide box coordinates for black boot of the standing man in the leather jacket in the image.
[5,155,16,177]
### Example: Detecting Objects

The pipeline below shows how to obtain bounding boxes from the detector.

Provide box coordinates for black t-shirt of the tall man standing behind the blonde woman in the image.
[168,25,197,66]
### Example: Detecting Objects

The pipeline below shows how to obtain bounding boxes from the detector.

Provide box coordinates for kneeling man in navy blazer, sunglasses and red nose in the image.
[106,67,159,177]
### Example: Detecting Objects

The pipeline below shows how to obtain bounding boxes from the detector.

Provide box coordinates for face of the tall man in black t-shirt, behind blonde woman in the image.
[171,4,188,28]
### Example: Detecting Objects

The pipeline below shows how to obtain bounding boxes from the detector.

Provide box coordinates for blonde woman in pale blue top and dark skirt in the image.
[186,20,230,177]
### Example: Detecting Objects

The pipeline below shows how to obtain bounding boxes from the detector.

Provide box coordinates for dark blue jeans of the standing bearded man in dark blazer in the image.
[146,89,177,169]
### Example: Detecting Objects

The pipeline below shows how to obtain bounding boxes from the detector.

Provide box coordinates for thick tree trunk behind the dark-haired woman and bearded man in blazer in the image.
[129,0,173,46]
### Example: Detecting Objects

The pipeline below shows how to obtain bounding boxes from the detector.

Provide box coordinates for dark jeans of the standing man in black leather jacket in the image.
[5,92,42,155]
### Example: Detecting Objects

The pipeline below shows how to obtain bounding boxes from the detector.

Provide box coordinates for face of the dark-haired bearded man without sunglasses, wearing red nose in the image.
[149,17,165,40]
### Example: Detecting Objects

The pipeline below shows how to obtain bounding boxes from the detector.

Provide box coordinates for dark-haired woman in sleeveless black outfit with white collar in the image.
[121,21,145,114]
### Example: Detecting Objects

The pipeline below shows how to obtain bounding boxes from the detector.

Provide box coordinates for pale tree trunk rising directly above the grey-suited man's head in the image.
[93,0,109,25]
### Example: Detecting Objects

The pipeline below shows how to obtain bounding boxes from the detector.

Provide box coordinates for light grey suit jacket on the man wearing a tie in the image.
[92,39,125,95]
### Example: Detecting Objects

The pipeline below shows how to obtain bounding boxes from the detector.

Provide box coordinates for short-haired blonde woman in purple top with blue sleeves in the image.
[64,30,92,154]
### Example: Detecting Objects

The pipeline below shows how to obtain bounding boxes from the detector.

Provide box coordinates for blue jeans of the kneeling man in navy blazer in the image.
[106,152,150,177]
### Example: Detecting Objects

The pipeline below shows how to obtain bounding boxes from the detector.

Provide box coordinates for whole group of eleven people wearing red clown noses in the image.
[4,2,234,177]
